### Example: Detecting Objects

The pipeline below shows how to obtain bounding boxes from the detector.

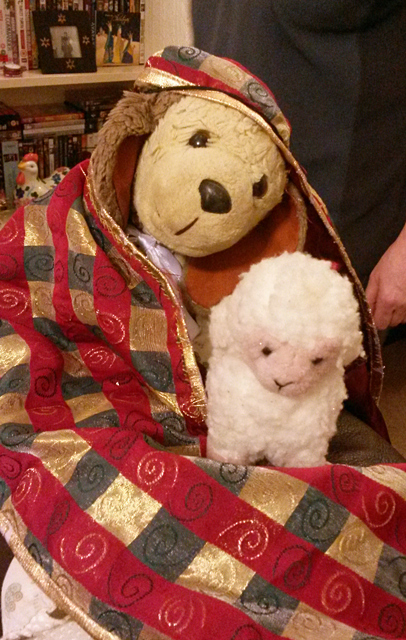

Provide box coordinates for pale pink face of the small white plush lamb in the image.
[241,329,343,397]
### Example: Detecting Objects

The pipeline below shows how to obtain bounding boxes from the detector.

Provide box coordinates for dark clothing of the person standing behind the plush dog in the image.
[193,0,406,284]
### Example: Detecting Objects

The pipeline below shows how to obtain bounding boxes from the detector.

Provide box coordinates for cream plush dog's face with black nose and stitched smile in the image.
[134,96,286,256]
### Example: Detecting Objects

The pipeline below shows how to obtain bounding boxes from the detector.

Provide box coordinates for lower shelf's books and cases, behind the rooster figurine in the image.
[0,84,132,210]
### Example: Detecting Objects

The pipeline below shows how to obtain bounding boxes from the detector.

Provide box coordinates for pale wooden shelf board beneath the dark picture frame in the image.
[0,65,144,91]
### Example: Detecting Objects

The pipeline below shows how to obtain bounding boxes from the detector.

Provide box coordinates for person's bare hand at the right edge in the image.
[366,227,406,330]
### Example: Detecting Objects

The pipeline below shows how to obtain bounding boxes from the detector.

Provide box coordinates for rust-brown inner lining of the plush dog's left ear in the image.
[113,135,148,228]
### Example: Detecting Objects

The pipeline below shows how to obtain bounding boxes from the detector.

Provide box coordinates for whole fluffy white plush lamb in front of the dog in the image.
[206,252,363,467]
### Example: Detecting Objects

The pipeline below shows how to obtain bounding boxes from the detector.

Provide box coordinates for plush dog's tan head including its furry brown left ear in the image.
[93,94,287,257]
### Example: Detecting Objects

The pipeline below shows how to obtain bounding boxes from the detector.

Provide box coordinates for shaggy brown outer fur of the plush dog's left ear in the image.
[90,91,181,228]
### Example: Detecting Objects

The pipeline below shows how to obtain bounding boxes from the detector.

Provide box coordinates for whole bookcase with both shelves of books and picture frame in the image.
[0,0,145,212]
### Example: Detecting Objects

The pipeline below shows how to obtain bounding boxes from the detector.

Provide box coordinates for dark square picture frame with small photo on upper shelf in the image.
[33,10,97,73]
